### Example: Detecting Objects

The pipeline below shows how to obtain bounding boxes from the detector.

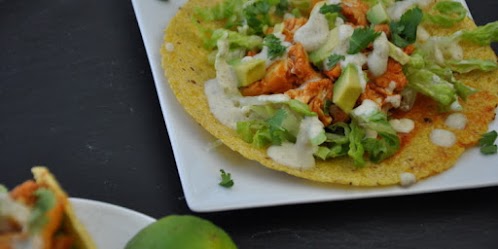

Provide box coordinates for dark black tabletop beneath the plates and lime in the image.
[0,0,498,248]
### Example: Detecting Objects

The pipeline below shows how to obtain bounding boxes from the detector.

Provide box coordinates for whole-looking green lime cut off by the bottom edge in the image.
[125,215,237,249]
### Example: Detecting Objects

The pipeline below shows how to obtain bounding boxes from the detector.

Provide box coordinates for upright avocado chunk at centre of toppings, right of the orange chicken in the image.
[332,64,363,113]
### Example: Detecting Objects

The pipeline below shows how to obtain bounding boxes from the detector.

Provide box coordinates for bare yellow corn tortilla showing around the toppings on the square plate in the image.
[161,0,498,186]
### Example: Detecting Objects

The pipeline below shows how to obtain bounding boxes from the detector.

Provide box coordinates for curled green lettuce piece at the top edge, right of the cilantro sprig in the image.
[424,1,467,28]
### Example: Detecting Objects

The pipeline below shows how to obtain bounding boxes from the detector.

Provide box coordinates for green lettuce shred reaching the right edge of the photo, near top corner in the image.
[457,21,498,46]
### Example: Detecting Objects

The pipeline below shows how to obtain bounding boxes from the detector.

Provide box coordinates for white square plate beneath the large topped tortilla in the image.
[132,0,498,212]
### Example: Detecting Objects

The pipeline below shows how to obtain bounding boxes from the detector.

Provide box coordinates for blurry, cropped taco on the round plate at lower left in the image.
[0,167,95,249]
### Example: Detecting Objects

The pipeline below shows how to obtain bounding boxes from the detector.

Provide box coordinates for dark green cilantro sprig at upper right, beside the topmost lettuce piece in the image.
[390,7,424,48]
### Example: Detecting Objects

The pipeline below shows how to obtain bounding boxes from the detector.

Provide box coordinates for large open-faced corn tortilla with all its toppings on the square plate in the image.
[162,0,498,185]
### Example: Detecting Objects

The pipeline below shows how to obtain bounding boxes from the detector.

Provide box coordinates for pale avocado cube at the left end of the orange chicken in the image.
[231,59,266,87]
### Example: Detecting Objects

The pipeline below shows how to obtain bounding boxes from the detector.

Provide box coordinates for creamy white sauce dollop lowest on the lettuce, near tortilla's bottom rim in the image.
[267,116,323,169]
